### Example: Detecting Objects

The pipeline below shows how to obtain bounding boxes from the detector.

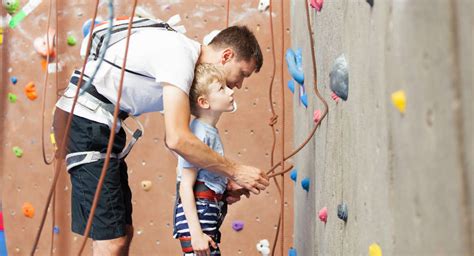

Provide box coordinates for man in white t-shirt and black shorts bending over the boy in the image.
[54,19,269,255]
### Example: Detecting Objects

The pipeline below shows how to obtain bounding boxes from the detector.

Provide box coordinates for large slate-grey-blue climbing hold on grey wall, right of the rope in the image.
[329,54,349,100]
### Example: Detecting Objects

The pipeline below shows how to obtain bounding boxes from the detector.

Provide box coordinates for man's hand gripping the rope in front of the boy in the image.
[232,165,270,195]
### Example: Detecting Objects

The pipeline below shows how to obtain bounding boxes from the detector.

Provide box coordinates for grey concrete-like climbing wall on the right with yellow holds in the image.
[290,0,474,255]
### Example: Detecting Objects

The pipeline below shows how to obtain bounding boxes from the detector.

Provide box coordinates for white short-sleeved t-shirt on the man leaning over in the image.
[56,28,201,126]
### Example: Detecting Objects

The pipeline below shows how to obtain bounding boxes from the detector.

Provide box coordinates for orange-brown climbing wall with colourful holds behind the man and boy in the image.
[0,0,293,255]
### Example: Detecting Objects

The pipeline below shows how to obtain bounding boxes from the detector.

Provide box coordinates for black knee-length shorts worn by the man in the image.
[64,112,132,240]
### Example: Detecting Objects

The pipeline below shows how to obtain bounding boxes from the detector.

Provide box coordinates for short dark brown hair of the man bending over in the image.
[209,26,263,73]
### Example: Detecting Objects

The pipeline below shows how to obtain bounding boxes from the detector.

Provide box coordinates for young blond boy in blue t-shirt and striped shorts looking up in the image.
[173,64,235,255]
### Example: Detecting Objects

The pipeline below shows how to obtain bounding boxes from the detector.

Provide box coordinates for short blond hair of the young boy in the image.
[189,63,226,116]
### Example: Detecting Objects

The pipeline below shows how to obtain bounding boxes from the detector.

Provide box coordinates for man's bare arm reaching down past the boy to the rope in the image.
[163,83,270,194]
